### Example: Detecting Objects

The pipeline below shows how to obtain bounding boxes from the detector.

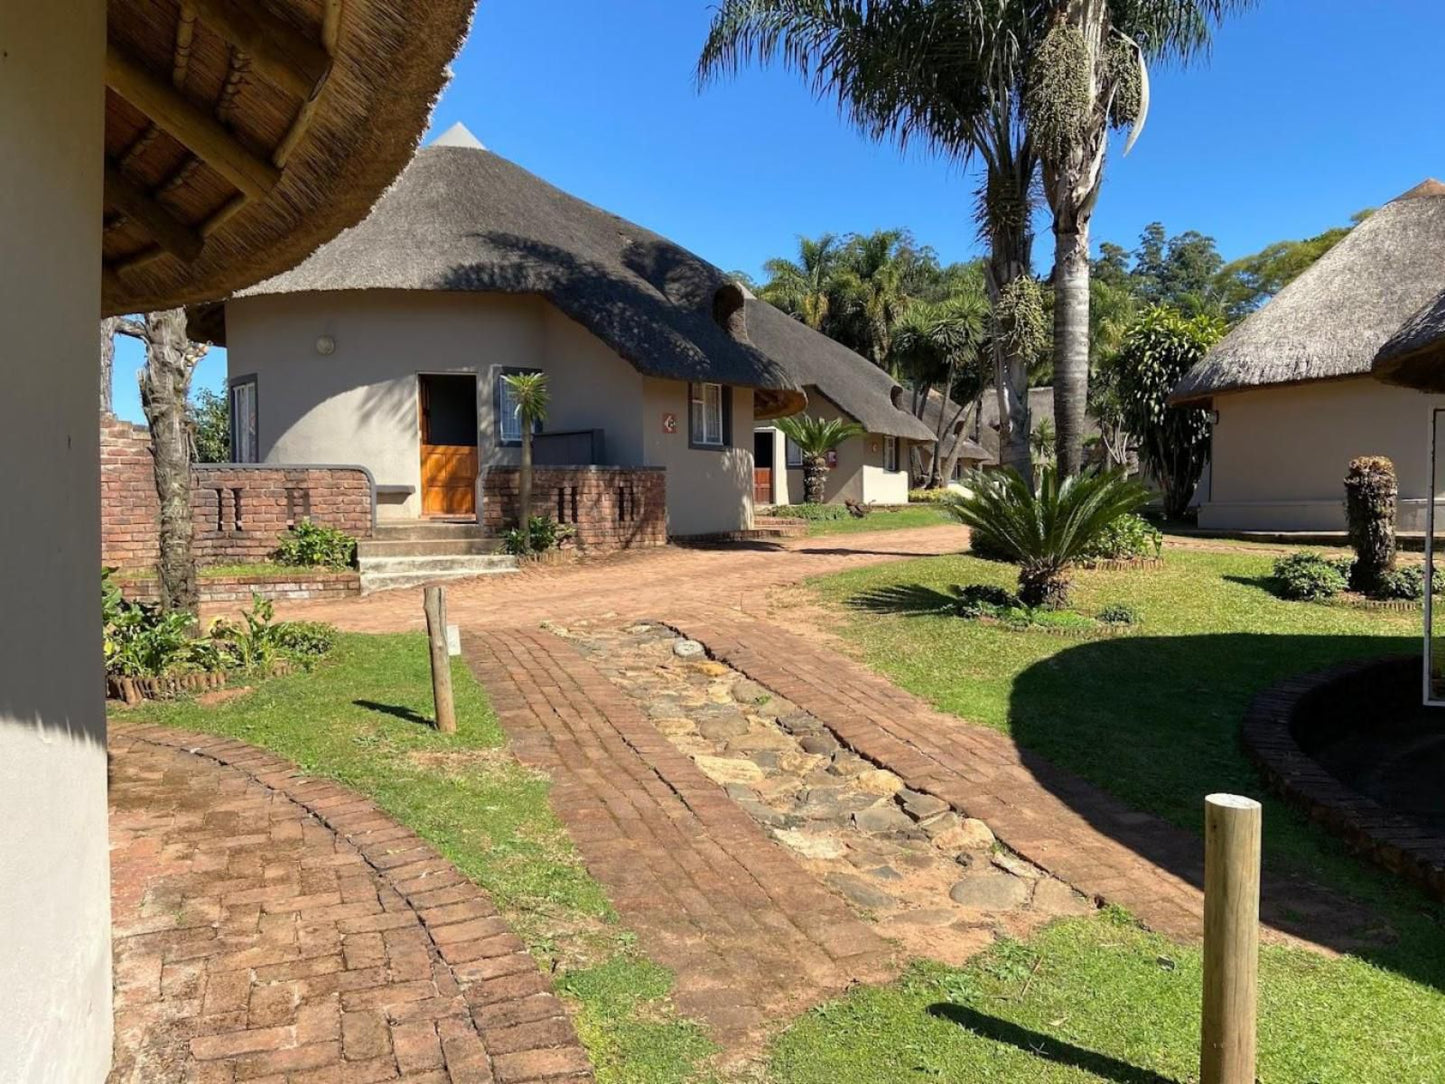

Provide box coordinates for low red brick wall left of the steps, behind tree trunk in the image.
[100,419,371,568]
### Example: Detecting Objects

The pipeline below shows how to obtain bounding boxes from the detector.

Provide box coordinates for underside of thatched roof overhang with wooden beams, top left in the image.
[104,0,473,314]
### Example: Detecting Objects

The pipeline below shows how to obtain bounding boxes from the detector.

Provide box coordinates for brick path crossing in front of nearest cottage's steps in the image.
[264,525,968,632]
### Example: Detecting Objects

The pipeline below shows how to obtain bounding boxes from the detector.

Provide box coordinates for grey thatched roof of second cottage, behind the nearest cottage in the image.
[743,299,933,441]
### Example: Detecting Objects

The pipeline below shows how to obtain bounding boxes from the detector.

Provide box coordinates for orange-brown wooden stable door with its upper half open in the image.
[418,374,478,516]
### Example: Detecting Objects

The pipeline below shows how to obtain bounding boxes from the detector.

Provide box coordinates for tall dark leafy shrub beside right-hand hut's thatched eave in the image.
[1113,306,1224,519]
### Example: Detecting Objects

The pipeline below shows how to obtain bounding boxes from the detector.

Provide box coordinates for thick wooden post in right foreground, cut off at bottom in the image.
[1199,793,1261,1084]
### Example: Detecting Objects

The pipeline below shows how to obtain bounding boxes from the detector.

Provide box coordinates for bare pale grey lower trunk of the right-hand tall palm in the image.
[1053,218,1090,477]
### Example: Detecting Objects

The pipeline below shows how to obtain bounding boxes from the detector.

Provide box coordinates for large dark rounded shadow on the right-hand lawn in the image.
[1009,633,1445,990]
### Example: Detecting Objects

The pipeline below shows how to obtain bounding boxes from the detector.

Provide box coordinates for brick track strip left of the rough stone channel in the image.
[464,630,894,1048]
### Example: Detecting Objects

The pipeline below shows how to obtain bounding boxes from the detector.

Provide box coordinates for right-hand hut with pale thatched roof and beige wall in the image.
[1173,181,1445,530]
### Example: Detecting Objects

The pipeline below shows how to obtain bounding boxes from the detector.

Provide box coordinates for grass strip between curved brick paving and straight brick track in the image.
[121,635,712,1084]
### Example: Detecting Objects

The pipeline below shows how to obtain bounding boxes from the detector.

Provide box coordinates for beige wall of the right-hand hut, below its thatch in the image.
[1199,377,1445,530]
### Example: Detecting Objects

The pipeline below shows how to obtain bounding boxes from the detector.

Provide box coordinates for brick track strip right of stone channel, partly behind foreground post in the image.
[675,617,1373,948]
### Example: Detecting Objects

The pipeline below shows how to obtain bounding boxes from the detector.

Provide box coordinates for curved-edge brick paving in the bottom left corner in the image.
[110,724,591,1084]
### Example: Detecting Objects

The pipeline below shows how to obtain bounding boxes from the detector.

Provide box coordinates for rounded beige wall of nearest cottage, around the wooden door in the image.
[225,291,643,516]
